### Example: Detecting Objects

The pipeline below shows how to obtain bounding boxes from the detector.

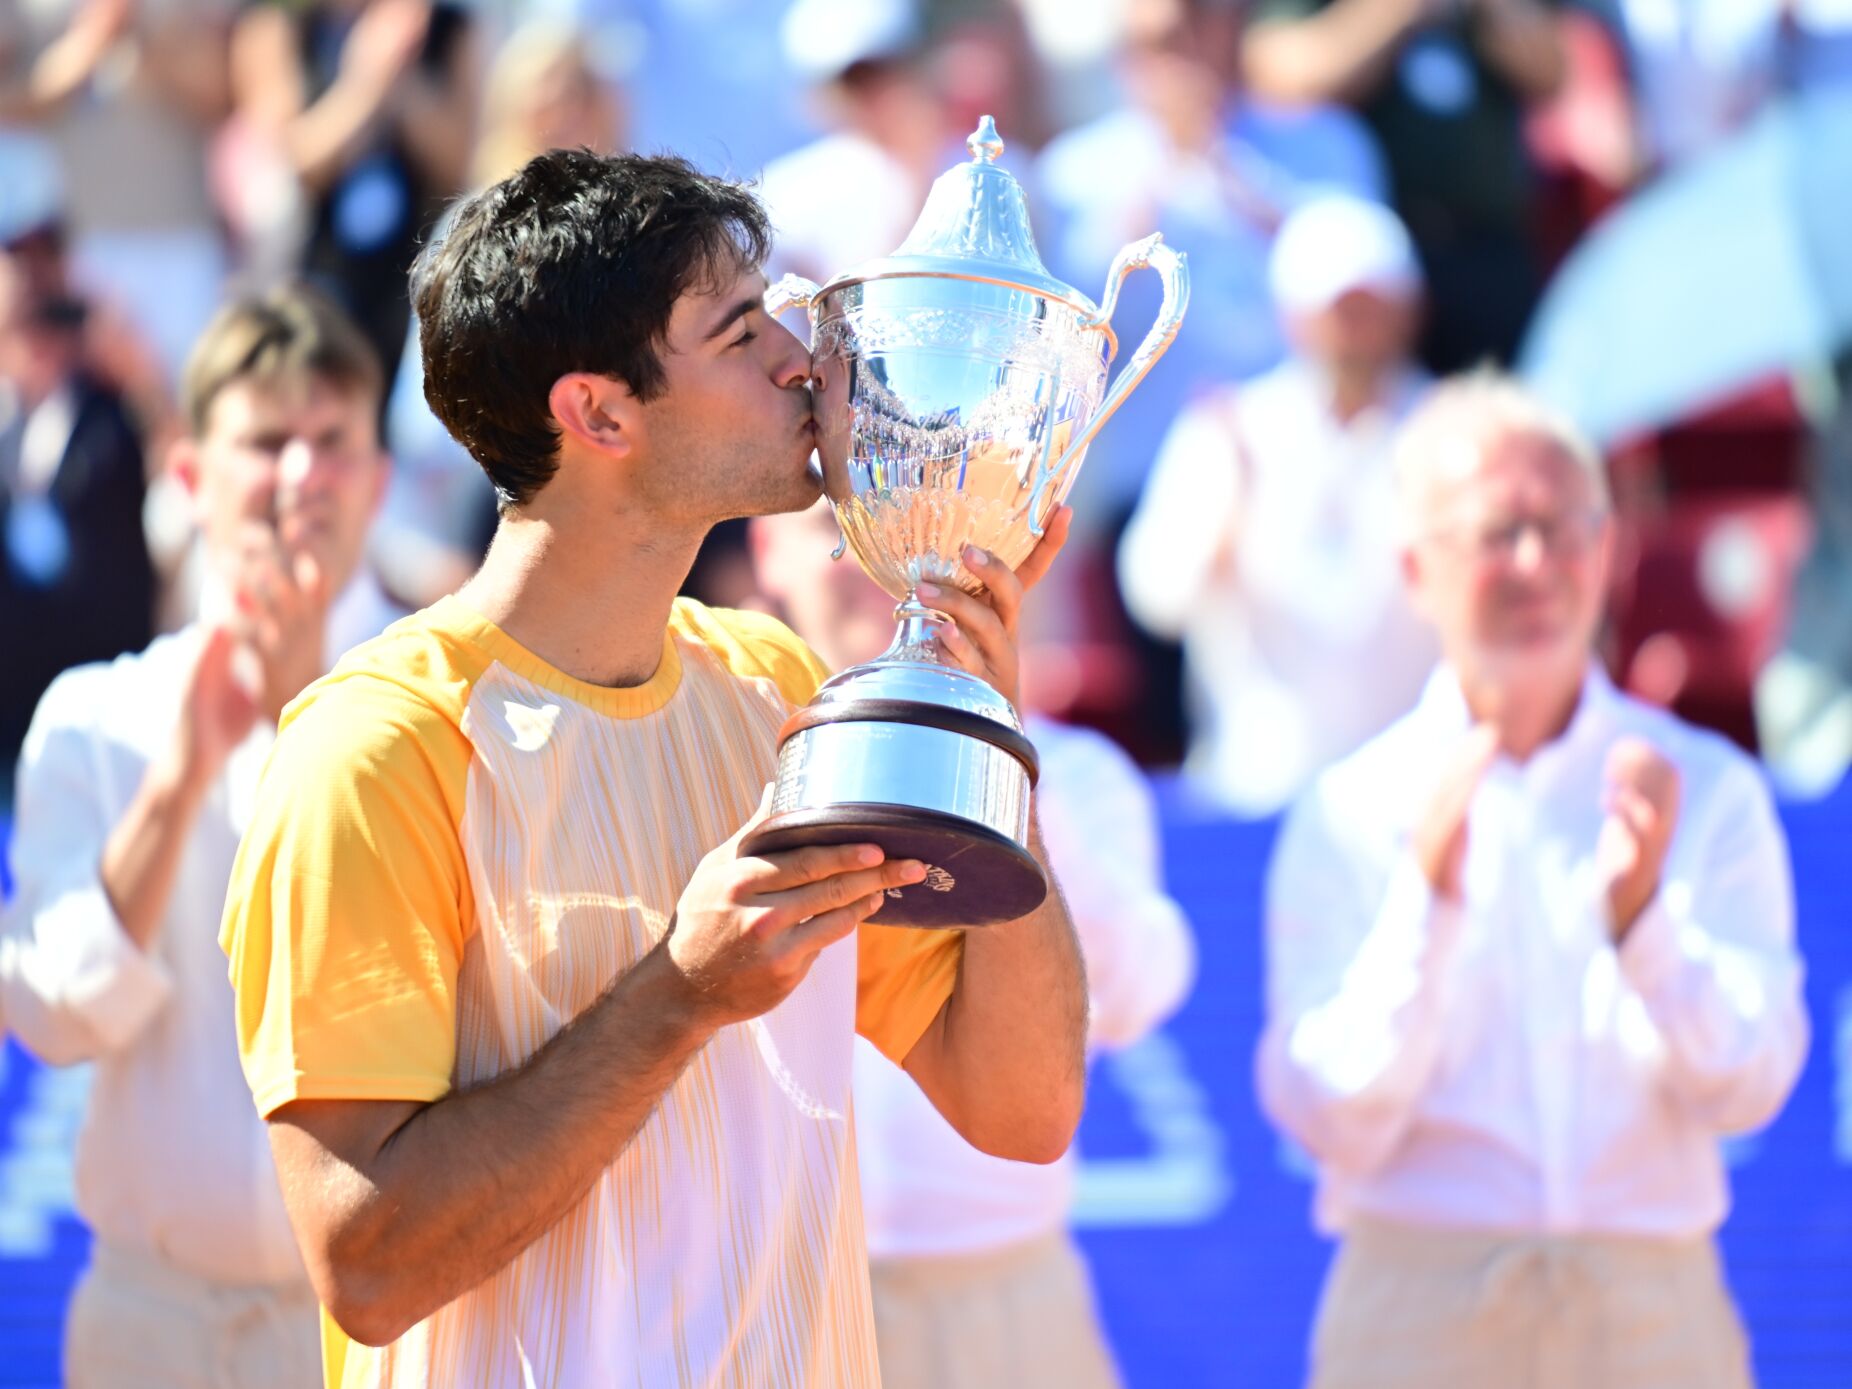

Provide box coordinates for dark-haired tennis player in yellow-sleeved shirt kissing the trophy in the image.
[222,152,1085,1389]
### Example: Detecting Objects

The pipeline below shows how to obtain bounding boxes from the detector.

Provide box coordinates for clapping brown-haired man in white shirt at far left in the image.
[0,291,393,1389]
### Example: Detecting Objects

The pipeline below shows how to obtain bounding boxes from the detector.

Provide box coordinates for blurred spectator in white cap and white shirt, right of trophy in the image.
[1119,194,1435,815]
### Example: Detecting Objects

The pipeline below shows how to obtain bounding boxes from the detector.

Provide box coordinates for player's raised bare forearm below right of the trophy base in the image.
[907,814,1087,1163]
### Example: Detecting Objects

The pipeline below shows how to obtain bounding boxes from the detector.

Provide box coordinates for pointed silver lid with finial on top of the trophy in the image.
[830,117,1093,311]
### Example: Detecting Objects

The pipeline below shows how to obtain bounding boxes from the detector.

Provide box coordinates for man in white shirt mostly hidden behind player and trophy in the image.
[750,502,1196,1389]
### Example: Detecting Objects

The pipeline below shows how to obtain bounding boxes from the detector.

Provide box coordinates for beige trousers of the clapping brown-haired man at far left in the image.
[65,1243,322,1389]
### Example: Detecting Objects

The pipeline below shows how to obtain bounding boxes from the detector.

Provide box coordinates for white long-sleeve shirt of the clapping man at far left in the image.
[0,580,396,1287]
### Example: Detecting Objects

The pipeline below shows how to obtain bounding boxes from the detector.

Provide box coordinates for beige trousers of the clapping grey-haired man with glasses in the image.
[1311,1222,1752,1389]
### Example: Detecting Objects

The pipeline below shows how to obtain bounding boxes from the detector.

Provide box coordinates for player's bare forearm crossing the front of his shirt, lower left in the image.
[309,948,711,1345]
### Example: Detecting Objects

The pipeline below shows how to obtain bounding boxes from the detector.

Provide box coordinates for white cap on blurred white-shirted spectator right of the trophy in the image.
[1267,193,1420,315]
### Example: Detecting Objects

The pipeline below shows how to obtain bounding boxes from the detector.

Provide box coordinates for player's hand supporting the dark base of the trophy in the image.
[665,789,926,1028]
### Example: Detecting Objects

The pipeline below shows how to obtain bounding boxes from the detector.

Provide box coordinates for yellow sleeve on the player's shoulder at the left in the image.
[219,672,474,1117]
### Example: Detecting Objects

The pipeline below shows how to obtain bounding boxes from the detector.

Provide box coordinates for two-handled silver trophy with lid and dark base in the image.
[746,117,1189,926]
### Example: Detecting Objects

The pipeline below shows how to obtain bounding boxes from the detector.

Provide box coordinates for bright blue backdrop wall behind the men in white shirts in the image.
[0,785,1852,1389]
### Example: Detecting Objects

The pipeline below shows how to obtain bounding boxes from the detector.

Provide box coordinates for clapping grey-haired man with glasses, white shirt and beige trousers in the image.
[1258,376,1808,1389]
